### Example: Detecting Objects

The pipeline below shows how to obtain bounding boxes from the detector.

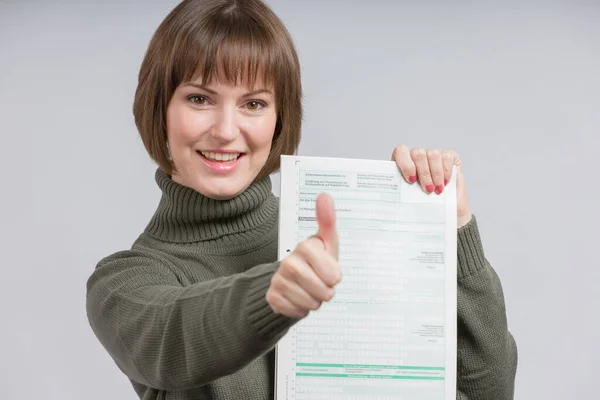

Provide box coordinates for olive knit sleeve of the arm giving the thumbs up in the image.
[86,250,297,390]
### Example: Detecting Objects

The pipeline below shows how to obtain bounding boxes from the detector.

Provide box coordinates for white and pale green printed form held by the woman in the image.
[275,156,457,400]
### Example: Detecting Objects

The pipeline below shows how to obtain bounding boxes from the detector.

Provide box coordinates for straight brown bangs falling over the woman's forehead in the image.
[172,15,286,88]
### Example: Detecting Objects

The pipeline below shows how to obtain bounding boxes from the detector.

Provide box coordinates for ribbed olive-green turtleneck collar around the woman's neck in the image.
[145,168,278,243]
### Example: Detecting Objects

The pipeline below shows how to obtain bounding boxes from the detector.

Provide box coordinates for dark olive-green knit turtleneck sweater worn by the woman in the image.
[87,169,517,400]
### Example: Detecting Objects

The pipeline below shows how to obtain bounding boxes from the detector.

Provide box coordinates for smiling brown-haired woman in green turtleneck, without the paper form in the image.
[87,0,516,400]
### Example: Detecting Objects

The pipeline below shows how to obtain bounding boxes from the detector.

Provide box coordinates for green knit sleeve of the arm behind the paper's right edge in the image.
[456,216,517,400]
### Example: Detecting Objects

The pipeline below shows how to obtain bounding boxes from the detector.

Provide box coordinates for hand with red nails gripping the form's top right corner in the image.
[392,144,471,228]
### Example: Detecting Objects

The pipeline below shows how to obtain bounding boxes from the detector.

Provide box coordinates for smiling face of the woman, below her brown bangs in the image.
[167,74,277,200]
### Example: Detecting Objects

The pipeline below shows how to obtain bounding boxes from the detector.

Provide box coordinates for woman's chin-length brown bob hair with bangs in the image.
[133,0,302,180]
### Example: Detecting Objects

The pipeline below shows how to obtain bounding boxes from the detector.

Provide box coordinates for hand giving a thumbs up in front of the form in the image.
[266,193,342,319]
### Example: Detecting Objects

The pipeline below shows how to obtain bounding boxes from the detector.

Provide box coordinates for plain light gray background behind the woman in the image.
[0,0,600,400]
